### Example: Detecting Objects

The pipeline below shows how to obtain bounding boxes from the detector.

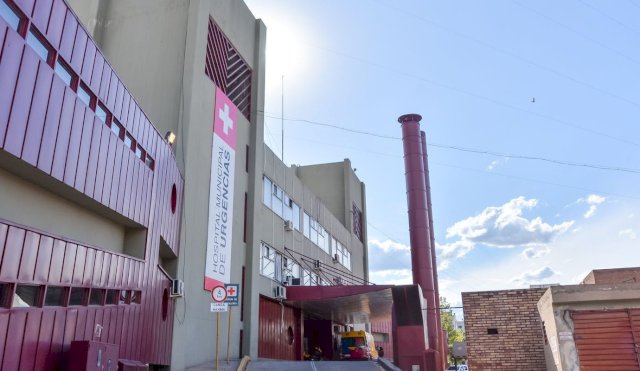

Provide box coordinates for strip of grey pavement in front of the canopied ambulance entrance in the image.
[247,360,383,371]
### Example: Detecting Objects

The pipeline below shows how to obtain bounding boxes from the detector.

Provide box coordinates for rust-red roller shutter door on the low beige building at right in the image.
[572,309,640,371]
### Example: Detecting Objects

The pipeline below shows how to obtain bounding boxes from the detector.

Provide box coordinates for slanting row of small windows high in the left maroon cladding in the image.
[0,0,155,170]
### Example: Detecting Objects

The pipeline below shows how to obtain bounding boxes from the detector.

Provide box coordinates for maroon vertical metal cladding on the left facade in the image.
[0,0,183,370]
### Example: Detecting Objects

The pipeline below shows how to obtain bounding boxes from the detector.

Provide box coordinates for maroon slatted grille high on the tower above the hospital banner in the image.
[205,18,252,120]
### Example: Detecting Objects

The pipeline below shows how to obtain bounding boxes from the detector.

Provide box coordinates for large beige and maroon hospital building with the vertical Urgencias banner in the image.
[0,0,368,370]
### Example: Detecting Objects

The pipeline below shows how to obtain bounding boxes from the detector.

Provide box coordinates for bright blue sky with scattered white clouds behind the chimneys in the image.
[246,0,640,310]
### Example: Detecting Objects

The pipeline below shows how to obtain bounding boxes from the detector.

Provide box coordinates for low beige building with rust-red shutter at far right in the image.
[538,278,640,371]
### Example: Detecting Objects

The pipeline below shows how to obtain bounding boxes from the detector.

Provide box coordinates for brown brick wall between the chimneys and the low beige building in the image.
[462,288,547,371]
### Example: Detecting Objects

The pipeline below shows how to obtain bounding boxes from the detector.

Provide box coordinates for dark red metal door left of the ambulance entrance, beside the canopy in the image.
[258,296,302,360]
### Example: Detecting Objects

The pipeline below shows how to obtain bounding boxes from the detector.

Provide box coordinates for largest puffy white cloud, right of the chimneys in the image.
[447,196,574,247]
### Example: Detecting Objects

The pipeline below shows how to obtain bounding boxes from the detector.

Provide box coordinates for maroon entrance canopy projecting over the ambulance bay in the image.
[286,285,397,324]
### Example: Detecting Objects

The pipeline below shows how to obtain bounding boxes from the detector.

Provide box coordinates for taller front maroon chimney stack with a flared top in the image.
[398,114,440,351]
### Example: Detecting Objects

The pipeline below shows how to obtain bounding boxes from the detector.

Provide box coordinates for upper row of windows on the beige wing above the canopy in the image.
[263,176,351,270]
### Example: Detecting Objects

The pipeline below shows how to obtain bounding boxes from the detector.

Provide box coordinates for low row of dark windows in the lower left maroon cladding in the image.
[0,282,142,308]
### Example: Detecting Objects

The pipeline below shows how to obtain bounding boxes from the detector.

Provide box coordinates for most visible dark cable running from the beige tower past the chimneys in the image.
[259,111,640,174]
